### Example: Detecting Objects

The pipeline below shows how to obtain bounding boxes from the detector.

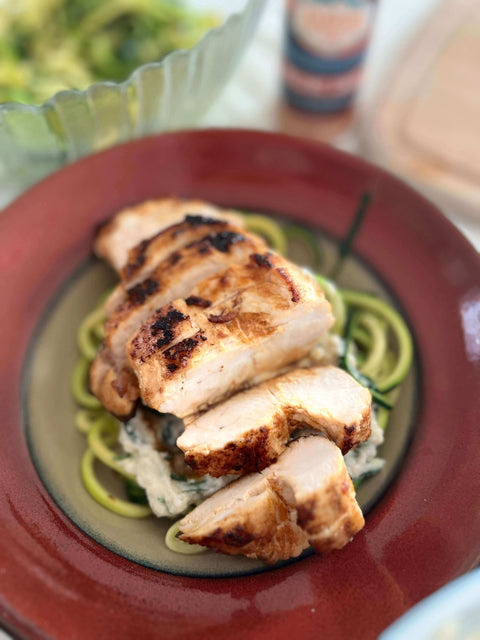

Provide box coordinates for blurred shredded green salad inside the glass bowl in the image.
[0,0,218,104]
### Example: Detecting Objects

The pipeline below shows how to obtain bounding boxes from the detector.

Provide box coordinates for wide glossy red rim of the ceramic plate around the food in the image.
[0,131,480,639]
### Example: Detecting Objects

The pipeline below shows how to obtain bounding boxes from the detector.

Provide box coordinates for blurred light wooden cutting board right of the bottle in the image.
[362,0,480,218]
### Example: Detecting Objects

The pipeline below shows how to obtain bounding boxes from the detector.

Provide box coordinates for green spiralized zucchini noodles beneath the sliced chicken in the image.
[72,203,413,554]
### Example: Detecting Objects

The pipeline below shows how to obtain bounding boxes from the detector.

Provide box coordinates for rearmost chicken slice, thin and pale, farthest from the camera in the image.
[94,198,243,273]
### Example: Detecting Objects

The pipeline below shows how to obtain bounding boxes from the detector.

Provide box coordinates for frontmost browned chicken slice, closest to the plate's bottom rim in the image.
[180,436,365,563]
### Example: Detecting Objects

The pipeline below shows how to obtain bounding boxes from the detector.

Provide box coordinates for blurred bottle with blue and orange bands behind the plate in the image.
[283,0,372,114]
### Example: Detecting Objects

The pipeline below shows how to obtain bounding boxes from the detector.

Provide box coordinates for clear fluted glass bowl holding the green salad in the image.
[0,0,265,206]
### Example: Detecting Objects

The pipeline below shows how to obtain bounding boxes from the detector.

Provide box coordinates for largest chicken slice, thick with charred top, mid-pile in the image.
[127,253,333,418]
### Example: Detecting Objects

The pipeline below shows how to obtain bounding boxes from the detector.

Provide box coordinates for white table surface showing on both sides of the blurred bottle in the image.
[0,0,480,640]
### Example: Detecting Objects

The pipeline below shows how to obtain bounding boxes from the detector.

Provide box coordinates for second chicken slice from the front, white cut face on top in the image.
[177,366,371,477]
